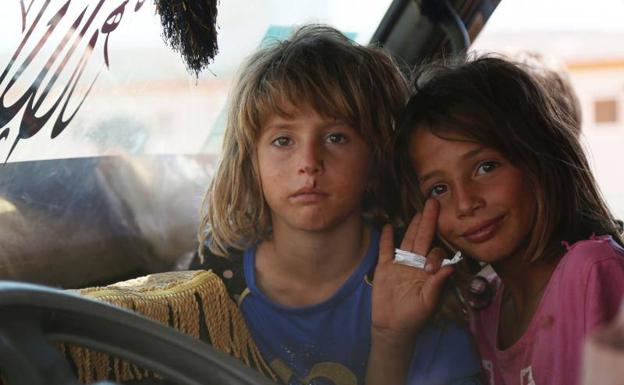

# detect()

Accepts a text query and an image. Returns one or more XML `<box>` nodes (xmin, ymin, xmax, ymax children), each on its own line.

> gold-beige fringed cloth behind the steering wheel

<box><xmin>59</xmin><ymin>270</ymin><xmax>275</xmax><ymax>383</ymax></box>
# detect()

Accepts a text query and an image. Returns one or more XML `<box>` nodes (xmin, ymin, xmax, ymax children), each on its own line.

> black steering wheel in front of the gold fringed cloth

<box><xmin>0</xmin><ymin>281</ymin><xmax>272</xmax><ymax>385</ymax></box>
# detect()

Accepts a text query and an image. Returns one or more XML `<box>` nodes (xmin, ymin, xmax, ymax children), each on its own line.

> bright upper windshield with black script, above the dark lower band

<box><xmin>0</xmin><ymin>0</ymin><xmax>390</xmax><ymax>162</ymax></box>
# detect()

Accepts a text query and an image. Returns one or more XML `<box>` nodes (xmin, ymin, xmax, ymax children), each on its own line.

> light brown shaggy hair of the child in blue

<box><xmin>199</xmin><ymin>25</ymin><xmax>408</xmax><ymax>256</ymax></box>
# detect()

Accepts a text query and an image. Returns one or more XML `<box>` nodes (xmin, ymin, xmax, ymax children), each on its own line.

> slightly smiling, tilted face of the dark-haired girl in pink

<box><xmin>409</xmin><ymin>127</ymin><xmax>537</xmax><ymax>263</ymax></box>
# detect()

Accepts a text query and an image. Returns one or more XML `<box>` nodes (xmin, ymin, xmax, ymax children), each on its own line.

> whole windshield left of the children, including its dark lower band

<box><xmin>0</xmin><ymin>0</ymin><xmax>391</xmax><ymax>287</ymax></box>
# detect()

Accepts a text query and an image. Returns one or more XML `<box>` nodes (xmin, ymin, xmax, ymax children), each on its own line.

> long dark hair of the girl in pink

<box><xmin>395</xmin><ymin>57</ymin><xmax>622</xmax><ymax>262</ymax></box>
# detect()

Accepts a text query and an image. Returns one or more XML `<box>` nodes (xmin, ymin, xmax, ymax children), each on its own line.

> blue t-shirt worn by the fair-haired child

<box><xmin>240</xmin><ymin>231</ymin><xmax>481</xmax><ymax>385</ymax></box>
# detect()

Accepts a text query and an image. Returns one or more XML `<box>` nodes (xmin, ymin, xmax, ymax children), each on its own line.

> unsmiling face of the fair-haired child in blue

<box><xmin>256</xmin><ymin>103</ymin><xmax>371</xmax><ymax>231</ymax></box>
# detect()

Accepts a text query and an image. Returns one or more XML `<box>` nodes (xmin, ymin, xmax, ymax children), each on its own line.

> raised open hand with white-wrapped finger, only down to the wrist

<box><xmin>372</xmin><ymin>199</ymin><xmax>453</xmax><ymax>342</ymax></box>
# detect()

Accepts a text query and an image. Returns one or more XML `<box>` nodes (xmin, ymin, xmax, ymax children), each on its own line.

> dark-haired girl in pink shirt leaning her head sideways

<box><xmin>382</xmin><ymin>57</ymin><xmax>624</xmax><ymax>385</ymax></box>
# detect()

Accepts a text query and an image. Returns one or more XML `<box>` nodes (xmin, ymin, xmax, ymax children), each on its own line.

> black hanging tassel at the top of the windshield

<box><xmin>154</xmin><ymin>0</ymin><xmax>218</xmax><ymax>76</ymax></box>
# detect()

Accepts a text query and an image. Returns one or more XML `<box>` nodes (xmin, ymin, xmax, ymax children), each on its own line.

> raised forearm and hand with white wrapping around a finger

<box><xmin>366</xmin><ymin>200</ymin><xmax>453</xmax><ymax>385</ymax></box>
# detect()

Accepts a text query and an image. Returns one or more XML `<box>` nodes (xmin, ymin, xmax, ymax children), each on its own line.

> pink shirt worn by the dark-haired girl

<box><xmin>471</xmin><ymin>236</ymin><xmax>624</xmax><ymax>385</ymax></box>
